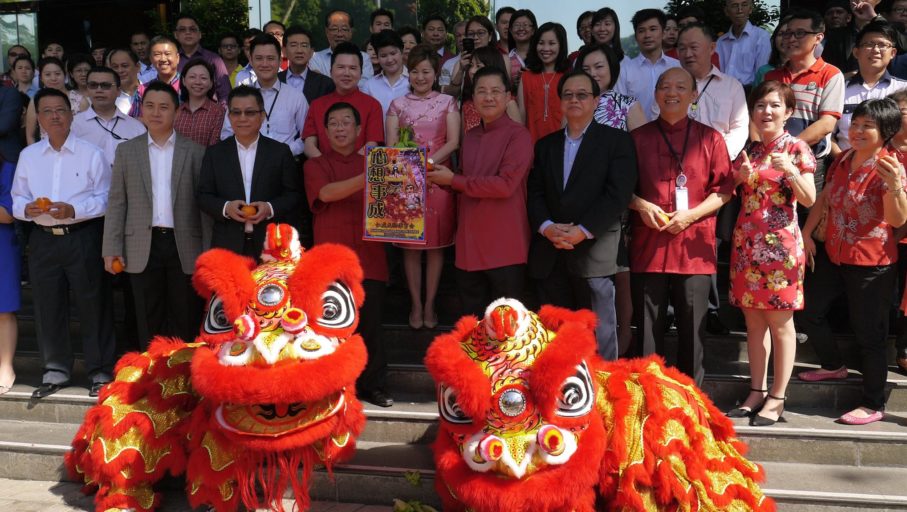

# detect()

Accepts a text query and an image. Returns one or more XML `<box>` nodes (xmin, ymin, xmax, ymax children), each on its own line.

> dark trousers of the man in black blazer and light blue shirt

<box><xmin>536</xmin><ymin>268</ymin><xmax>617</xmax><ymax>361</ymax></box>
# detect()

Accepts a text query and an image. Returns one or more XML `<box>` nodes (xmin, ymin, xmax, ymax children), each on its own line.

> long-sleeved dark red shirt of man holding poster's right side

<box><xmin>450</xmin><ymin>114</ymin><xmax>533</xmax><ymax>272</ymax></box>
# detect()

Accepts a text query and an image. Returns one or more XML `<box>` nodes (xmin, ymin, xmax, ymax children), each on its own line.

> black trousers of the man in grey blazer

<box><xmin>129</xmin><ymin>229</ymin><xmax>203</xmax><ymax>350</ymax></box>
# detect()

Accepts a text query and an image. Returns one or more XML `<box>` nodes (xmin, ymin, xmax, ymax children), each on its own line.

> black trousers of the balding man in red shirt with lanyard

<box><xmin>630</xmin><ymin>273</ymin><xmax>711</xmax><ymax>385</ymax></box>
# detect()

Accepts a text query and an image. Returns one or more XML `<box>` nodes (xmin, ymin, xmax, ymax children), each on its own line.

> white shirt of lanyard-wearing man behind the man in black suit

<box><xmin>220</xmin><ymin>80</ymin><xmax>309</xmax><ymax>156</ymax></box>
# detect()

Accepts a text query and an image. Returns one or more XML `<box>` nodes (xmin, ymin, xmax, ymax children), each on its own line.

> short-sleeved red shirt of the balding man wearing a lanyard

<box><xmin>630</xmin><ymin>118</ymin><xmax>734</xmax><ymax>274</ymax></box>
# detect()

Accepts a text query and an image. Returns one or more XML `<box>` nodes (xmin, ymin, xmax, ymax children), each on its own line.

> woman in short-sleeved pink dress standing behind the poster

<box><xmin>384</xmin><ymin>45</ymin><xmax>460</xmax><ymax>329</ymax></box>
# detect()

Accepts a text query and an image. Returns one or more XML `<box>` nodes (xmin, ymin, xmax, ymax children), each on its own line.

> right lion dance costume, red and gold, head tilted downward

<box><xmin>426</xmin><ymin>299</ymin><xmax>774</xmax><ymax>512</ymax></box>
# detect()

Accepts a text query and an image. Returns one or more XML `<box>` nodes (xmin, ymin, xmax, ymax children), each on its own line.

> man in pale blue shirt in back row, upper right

<box><xmin>718</xmin><ymin>0</ymin><xmax>772</xmax><ymax>87</ymax></box>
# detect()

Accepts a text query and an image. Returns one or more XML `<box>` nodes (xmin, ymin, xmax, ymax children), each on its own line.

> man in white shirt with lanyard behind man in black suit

<box><xmin>231</xmin><ymin>34</ymin><xmax>309</xmax><ymax>156</ymax></box>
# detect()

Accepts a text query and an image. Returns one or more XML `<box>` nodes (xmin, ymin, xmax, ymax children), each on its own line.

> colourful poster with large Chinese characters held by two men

<box><xmin>363</xmin><ymin>147</ymin><xmax>426</xmax><ymax>244</ymax></box>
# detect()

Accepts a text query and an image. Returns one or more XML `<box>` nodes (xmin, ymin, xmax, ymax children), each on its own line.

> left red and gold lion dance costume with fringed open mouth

<box><xmin>66</xmin><ymin>224</ymin><xmax>366</xmax><ymax>512</ymax></box>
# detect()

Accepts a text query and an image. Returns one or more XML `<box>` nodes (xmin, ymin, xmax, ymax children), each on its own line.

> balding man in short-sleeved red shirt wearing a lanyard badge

<box><xmin>630</xmin><ymin>68</ymin><xmax>734</xmax><ymax>383</ymax></box>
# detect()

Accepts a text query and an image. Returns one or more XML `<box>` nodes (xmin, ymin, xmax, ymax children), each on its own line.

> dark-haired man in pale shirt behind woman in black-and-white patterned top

<box><xmin>614</xmin><ymin>9</ymin><xmax>680</xmax><ymax>121</ymax></box>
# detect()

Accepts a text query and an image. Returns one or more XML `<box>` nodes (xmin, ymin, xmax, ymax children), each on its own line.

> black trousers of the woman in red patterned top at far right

<box><xmin>798</xmin><ymin>244</ymin><xmax>897</xmax><ymax>411</ymax></box>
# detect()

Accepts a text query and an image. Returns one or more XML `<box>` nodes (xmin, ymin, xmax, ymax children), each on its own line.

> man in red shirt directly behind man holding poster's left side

<box><xmin>302</xmin><ymin>43</ymin><xmax>384</xmax><ymax>158</ymax></box>
